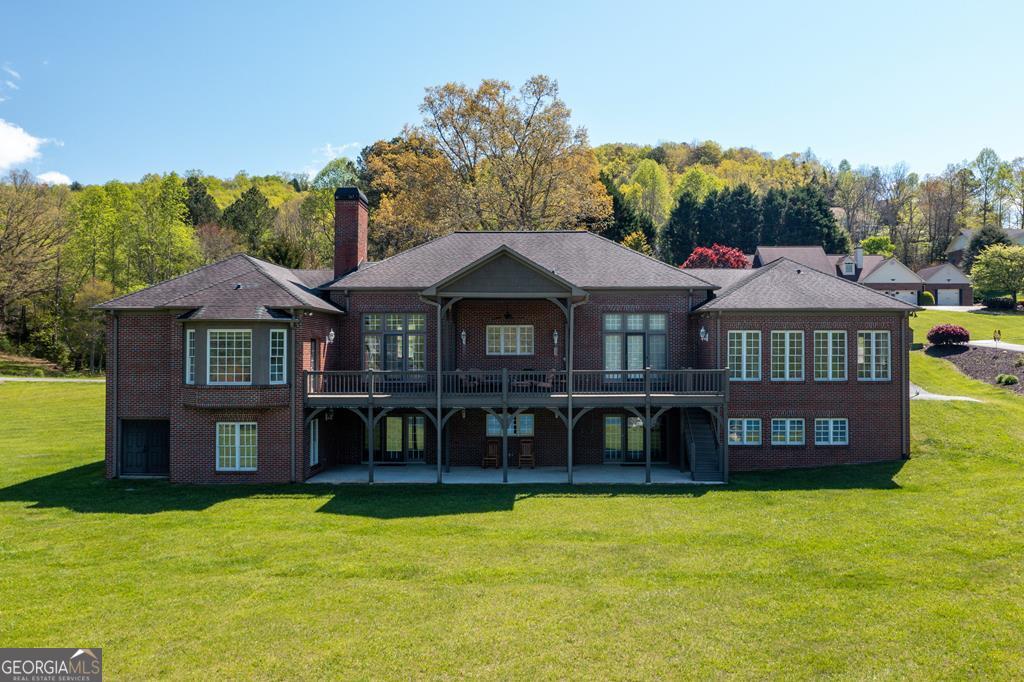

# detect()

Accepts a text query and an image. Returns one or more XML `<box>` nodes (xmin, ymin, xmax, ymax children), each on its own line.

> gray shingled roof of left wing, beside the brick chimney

<box><xmin>96</xmin><ymin>254</ymin><xmax>339</xmax><ymax>319</ymax></box>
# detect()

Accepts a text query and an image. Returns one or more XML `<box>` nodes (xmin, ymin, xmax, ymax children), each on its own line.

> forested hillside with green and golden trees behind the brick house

<box><xmin>6</xmin><ymin>76</ymin><xmax>1024</xmax><ymax>369</ymax></box>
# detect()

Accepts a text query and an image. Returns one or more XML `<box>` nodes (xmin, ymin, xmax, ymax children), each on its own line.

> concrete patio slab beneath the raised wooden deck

<box><xmin>306</xmin><ymin>464</ymin><xmax>703</xmax><ymax>485</ymax></box>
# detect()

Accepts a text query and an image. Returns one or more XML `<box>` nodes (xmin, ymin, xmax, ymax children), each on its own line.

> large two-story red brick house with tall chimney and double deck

<box><xmin>100</xmin><ymin>188</ymin><xmax>916</xmax><ymax>483</ymax></box>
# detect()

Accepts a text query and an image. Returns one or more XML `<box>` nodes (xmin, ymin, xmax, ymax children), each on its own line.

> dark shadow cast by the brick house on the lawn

<box><xmin>0</xmin><ymin>462</ymin><xmax>903</xmax><ymax>519</ymax></box>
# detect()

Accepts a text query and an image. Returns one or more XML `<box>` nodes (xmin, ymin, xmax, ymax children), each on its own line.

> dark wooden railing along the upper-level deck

<box><xmin>305</xmin><ymin>369</ymin><xmax>727</xmax><ymax>398</ymax></box>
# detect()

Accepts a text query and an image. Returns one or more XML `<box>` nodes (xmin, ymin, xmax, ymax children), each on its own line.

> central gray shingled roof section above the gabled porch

<box><xmin>330</xmin><ymin>231</ymin><xmax>714</xmax><ymax>289</ymax></box>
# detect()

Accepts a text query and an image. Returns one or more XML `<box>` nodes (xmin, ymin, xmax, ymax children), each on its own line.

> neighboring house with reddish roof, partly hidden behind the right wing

<box><xmin>752</xmin><ymin>241</ymin><xmax>925</xmax><ymax>305</ymax></box>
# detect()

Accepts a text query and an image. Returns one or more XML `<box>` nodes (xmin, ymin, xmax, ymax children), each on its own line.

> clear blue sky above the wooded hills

<box><xmin>0</xmin><ymin>0</ymin><xmax>1024</xmax><ymax>182</ymax></box>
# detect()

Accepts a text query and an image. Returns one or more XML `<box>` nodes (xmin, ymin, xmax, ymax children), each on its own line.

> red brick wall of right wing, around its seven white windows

<box><xmin>694</xmin><ymin>313</ymin><xmax>909</xmax><ymax>471</ymax></box>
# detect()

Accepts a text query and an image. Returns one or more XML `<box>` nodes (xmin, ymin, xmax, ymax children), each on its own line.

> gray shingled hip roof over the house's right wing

<box><xmin>699</xmin><ymin>258</ymin><xmax>920</xmax><ymax>310</ymax></box>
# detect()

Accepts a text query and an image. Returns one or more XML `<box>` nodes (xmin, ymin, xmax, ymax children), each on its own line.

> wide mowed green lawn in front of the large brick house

<box><xmin>0</xmin><ymin>366</ymin><xmax>1024</xmax><ymax>679</ymax></box>
